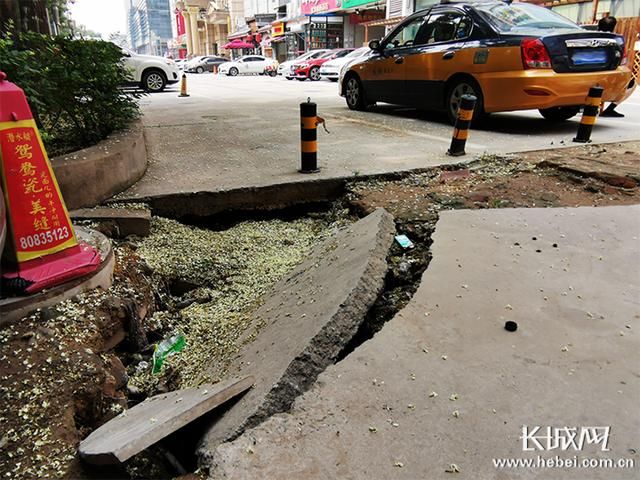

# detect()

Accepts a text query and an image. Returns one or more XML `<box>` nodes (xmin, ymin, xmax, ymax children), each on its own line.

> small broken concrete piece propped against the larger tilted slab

<box><xmin>78</xmin><ymin>376</ymin><xmax>255</xmax><ymax>465</ymax></box>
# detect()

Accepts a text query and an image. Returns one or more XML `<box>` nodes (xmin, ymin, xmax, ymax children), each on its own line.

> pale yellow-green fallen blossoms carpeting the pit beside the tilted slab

<box><xmin>129</xmin><ymin>218</ymin><xmax>348</xmax><ymax>392</ymax></box>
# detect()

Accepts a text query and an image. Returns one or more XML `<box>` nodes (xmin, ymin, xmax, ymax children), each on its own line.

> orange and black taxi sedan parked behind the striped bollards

<box><xmin>340</xmin><ymin>0</ymin><xmax>635</xmax><ymax>122</ymax></box>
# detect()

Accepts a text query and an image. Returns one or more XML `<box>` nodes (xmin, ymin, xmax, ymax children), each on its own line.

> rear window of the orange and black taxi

<box><xmin>476</xmin><ymin>3</ymin><xmax>580</xmax><ymax>33</ymax></box>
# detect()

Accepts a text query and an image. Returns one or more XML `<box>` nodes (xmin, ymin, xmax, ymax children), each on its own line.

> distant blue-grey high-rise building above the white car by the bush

<box><xmin>126</xmin><ymin>0</ymin><xmax>173</xmax><ymax>55</ymax></box>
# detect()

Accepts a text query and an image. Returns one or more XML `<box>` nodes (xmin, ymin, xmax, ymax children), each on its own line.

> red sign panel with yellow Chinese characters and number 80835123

<box><xmin>0</xmin><ymin>120</ymin><xmax>77</xmax><ymax>262</ymax></box>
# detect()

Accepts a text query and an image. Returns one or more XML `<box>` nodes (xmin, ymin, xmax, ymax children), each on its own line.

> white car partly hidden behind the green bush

<box><xmin>120</xmin><ymin>47</ymin><xmax>179</xmax><ymax>92</ymax></box>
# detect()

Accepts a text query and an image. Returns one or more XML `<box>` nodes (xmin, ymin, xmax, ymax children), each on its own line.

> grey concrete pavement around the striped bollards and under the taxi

<box><xmin>118</xmin><ymin>75</ymin><xmax>640</xmax><ymax>203</ymax></box>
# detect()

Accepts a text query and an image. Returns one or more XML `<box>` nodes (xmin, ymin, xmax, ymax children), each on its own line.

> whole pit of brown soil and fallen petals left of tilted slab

<box><xmin>0</xmin><ymin>216</ymin><xmax>342</xmax><ymax>479</ymax></box>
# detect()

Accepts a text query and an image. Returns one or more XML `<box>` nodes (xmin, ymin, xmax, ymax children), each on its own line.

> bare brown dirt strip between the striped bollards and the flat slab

<box><xmin>347</xmin><ymin>142</ymin><xmax>640</xmax><ymax>224</ymax></box>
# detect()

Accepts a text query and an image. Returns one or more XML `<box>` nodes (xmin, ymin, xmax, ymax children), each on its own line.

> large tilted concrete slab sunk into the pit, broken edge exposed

<box><xmin>199</xmin><ymin>209</ymin><xmax>395</xmax><ymax>463</ymax></box>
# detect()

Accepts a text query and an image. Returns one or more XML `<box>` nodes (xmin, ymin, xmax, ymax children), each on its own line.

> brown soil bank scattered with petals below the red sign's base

<box><xmin>0</xmin><ymin>246</ymin><xmax>161</xmax><ymax>478</ymax></box>
